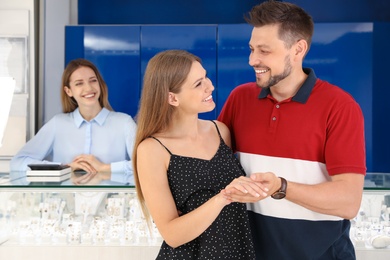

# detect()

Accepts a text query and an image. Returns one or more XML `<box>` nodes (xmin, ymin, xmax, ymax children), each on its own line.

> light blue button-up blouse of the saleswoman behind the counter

<box><xmin>10</xmin><ymin>108</ymin><xmax>136</xmax><ymax>185</ymax></box>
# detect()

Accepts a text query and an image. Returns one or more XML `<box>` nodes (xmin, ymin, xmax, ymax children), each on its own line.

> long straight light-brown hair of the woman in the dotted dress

<box><xmin>132</xmin><ymin>50</ymin><xmax>201</xmax><ymax>222</ymax></box>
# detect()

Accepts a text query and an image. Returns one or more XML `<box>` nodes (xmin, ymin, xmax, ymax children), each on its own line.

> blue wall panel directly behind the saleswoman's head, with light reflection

<box><xmin>65</xmin><ymin>26</ymin><xmax>141</xmax><ymax>116</ymax></box>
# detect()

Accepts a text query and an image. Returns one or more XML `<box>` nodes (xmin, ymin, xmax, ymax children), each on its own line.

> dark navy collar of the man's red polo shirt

<box><xmin>259</xmin><ymin>68</ymin><xmax>317</xmax><ymax>104</ymax></box>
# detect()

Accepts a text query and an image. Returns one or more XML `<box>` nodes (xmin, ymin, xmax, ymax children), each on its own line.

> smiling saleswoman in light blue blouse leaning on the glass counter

<box><xmin>10</xmin><ymin>59</ymin><xmax>136</xmax><ymax>183</ymax></box>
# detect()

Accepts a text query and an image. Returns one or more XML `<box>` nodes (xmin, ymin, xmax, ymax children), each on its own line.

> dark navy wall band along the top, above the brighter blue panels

<box><xmin>77</xmin><ymin>0</ymin><xmax>390</xmax><ymax>24</ymax></box>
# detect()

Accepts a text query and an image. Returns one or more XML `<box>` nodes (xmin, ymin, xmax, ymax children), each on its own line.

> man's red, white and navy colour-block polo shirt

<box><xmin>218</xmin><ymin>69</ymin><xmax>366</xmax><ymax>259</ymax></box>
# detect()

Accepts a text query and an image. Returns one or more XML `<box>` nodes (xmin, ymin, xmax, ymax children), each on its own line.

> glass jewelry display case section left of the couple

<box><xmin>0</xmin><ymin>173</ymin><xmax>162</xmax><ymax>260</ymax></box>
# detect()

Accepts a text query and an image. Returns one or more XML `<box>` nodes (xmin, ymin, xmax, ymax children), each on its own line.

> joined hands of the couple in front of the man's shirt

<box><xmin>225</xmin><ymin>172</ymin><xmax>280</xmax><ymax>203</ymax></box>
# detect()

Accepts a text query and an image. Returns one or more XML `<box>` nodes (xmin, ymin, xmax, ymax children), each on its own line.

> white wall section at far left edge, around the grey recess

<box><xmin>0</xmin><ymin>0</ymin><xmax>36</xmax><ymax>172</ymax></box>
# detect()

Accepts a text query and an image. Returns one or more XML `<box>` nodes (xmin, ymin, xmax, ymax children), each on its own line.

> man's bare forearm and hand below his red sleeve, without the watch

<box><xmin>227</xmin><ymin>172</ymin><xmax>364</xmax><ymax>219</ymax></box>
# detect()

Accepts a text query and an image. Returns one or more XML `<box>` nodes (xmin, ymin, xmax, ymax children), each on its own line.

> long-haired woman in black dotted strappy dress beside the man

<box><xmin>133</xmin><ymin>50</ymin><xmax>261</xmax><ymax>260</ymax></box>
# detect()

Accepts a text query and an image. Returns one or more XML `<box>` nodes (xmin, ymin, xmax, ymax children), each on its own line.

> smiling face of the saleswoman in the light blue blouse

<box><xmin>64</xmin><ymin>67</ymin><xmax>100</xmax><ymax>107</ymax></box>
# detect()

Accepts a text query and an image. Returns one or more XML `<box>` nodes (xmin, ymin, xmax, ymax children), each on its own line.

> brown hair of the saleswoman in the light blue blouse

<box><xmin>61</xmin><ymin>59</ymin><xmax>112</xmax><ymax>113</ymax></box>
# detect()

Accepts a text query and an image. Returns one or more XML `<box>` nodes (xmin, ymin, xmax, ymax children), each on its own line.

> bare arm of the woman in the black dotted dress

<box><xmin>137</xmin><ymin>139</ymin><xmax>231</xmax><ymax>247</ymax></box>
